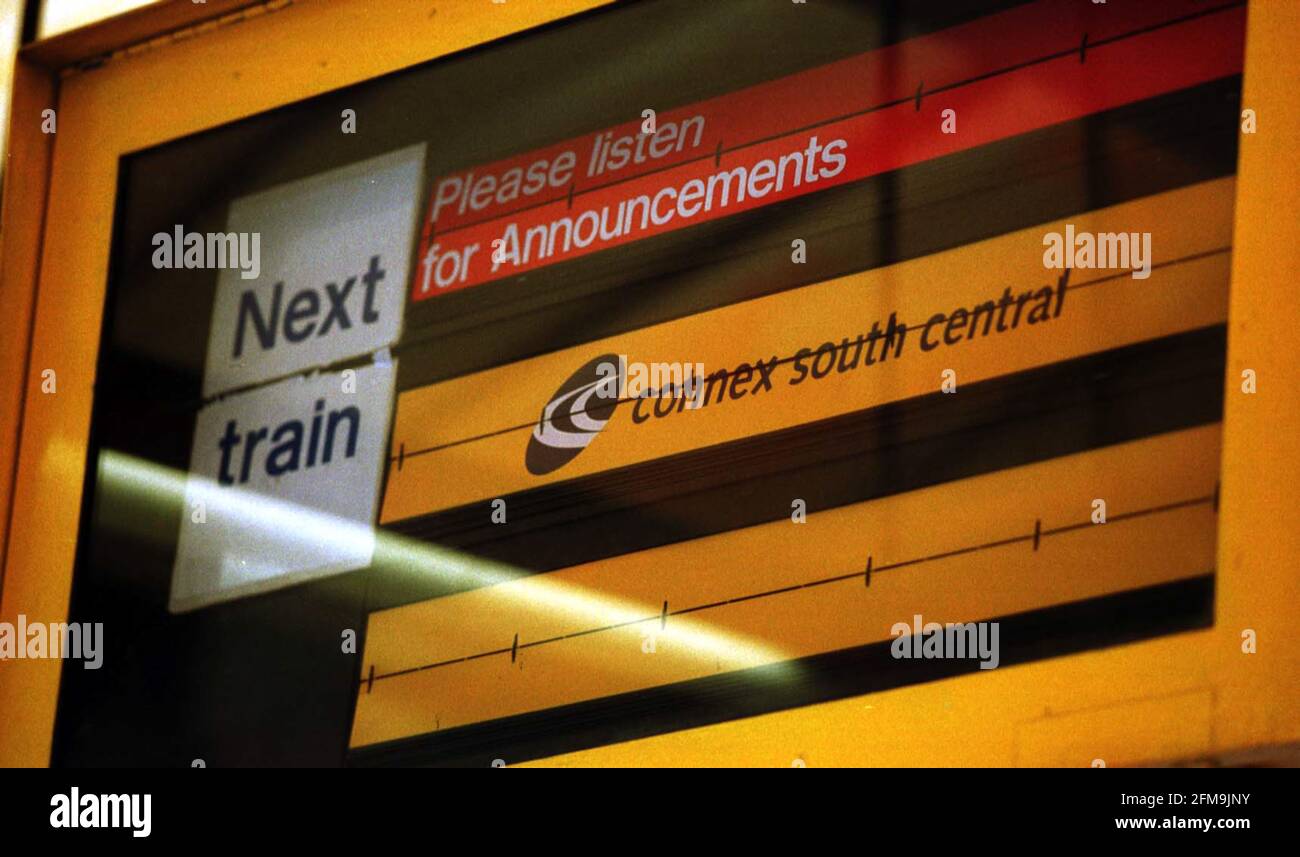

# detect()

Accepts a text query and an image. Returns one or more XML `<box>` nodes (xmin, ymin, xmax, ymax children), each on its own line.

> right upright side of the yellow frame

<box><xmin>1214</xmin><ymin>1</ymin><xmax>1300</xmax><ymax>748</ymax></box>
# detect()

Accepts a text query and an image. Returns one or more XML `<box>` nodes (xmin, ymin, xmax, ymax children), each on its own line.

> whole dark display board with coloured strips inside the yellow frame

<box><xmin>56</xmin><ymin>0</ymin><xmax>1247</xmax><ymax>765</ymax></box>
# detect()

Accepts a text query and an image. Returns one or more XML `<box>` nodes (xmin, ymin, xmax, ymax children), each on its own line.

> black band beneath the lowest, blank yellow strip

<box><xmin>347</xmin><ymin>577</ymin><xmax>1216</xmax><ymax>767</ymax></box>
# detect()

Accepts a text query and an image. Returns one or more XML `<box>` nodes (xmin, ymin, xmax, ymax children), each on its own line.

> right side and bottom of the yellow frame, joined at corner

<box><xmin>520</xmin><ymin>3</ymin><xmax>1300</xmax><ymax>767</ymax></box>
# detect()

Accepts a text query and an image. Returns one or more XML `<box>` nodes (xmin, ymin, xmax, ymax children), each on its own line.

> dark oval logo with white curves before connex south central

<box><xmin>524</xmin><ymin>354</ymin><xmax>621</xmax><ymax>476</ymax></box>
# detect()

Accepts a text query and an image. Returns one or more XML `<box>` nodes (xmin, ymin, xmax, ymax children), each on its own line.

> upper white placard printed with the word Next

<box><xmin>203</xmin><ymin>143</ymin><xmax>425</xmax><ymax>398</ymax></box>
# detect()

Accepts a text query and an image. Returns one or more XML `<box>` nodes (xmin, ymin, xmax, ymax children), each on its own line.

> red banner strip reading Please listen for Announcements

<box><xmin>412</xmin><ymin>0</ymin><xmax>1245</xmax><ymax>300</ymax></box>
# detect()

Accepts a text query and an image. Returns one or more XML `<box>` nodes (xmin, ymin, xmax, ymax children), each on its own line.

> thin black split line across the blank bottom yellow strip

<box><xmin>371</xmin><ymin>494</ymin><xmax>1214</xmax><ymax>683</ymax></box>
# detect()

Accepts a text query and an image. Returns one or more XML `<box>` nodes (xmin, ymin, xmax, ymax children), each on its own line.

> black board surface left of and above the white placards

<box><xmin>52</xmin><ymin>0</ymin><xmax>1045</xmax><ymax>767</ymax></box>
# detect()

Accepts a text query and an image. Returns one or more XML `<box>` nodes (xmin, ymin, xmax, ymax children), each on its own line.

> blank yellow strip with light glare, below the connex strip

<box><xmin>352</xmin><ymin>425</ymin><xmax>1219</xmax><ymax>745</ymax></box>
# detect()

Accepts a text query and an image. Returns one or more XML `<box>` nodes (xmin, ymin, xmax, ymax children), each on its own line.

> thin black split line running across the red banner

<box><xmin>429</xmin><ymin>0</ymin><xmax>1245</xmax><ymax>241</ymax></box>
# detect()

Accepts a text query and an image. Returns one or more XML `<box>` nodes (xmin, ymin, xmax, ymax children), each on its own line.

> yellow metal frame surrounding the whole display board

<box><xmin>0</xmin><ymin>0</ymin><xmax>1300</xmax><ymax>766</ymax></box>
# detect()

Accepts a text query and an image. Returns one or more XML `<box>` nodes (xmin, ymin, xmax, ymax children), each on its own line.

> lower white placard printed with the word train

<box><xmin>169</xmin><ymin>363</ymin><xmax>395</xmax><ymax>613</ymax></box>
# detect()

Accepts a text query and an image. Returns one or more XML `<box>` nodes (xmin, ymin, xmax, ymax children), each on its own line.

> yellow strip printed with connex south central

<box><xmin>381</xmin><ymin>178</ymin><xmax>1234</xmax><ymax>523</ymax></box>
